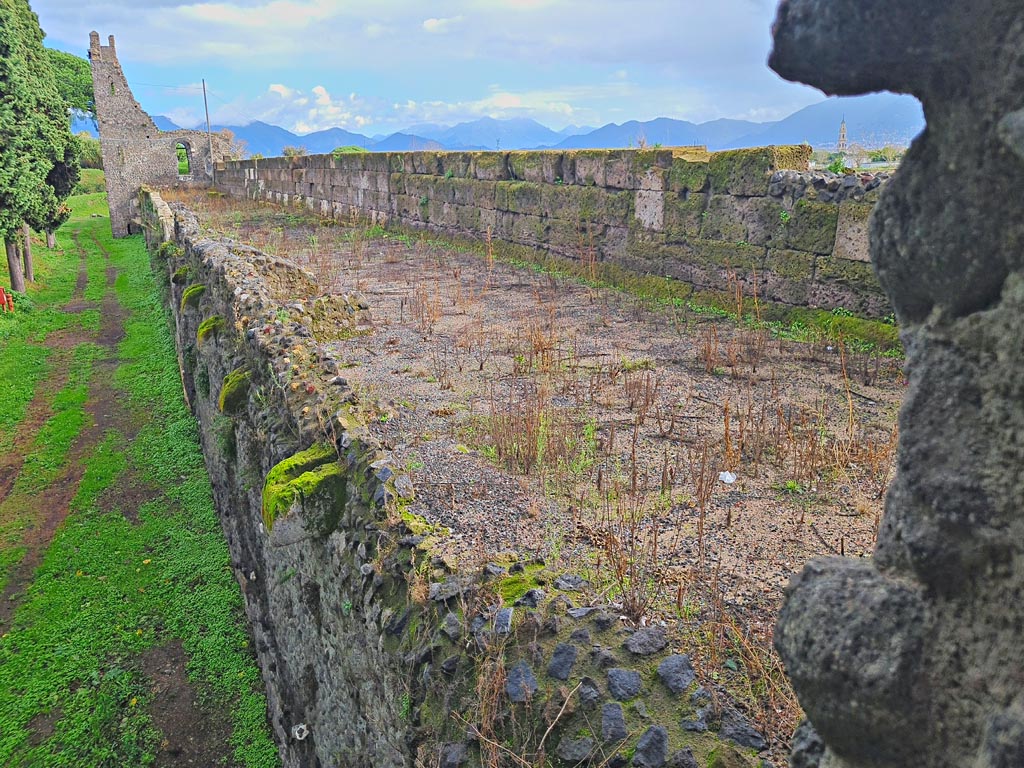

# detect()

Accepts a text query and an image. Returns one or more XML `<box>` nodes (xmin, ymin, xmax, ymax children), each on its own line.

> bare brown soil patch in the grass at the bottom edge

<box><xmin>142</xmin><ymin>640</ymin><xmax>236</xmax><ymax>768</ymax></box>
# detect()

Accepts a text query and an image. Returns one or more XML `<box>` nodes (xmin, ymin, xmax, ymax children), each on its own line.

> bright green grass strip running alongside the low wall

<box><xmin>0</xmin><ymin>198</ymin><xmax>279</xmax><ymax>768</ymax></box>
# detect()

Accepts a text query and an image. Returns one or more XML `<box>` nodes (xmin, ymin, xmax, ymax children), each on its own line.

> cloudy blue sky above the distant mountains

<box><xmin>31</xmin><ymin>0</ymin><xmax>822</xmax><ymax>134</ymax></box>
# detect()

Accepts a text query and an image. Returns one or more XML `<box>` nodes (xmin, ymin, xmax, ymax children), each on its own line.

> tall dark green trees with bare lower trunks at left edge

<box><xmin>0</xmin><ymin>0</ymin><xmax>92</xmax><ymax>292</ymax></box>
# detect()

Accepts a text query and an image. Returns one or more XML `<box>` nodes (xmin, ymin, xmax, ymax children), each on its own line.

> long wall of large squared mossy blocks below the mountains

<box><xmin>217</xmin><ymin>146</ymin><xmax>891</xmax><ymax>316</ymax></box>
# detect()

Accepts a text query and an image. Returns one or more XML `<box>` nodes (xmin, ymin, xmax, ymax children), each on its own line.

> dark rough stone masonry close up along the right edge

<box><xmin>770</xmin><ymin>0</ymin><xmax>1024</xmax><ymax>768</ymax></box>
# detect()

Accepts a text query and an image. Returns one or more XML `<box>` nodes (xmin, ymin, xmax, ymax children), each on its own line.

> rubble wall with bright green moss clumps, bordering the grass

<box><xmin>140</xmin><ymin>190</ymin><xmax>766</xmax><ymax>768</ymax></box>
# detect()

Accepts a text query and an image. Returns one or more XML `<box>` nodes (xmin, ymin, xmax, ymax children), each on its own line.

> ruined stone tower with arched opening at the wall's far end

<box><xmin>89</xmin><ymin>32</ymin><xmax>228</xmax><ymax>238</ymax></box>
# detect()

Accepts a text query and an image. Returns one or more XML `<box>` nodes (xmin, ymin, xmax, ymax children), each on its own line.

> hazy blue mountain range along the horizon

<box><xmin>72</xmin><ymin>93</ymin><xmax>925</xmax><ymax>157</ymax></box>
